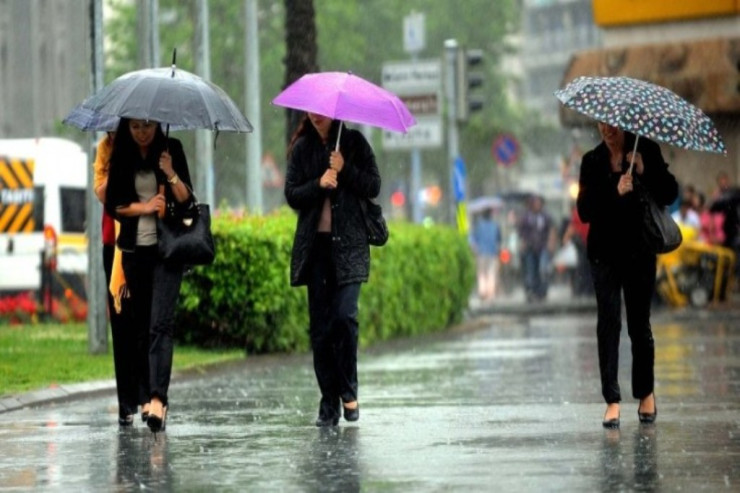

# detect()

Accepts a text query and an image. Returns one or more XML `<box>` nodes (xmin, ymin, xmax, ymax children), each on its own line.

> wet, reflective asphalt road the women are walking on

<box><xmin>0</xmin><ymin>314</ymin><xmax>740</xmax><ymax>492</ymax></box>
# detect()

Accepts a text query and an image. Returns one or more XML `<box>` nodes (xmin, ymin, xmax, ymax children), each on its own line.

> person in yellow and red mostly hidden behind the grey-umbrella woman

<box><xmin>93</xmin><ymin>132</ymin><xmax>142</xmax><ymax>426</ymax></box>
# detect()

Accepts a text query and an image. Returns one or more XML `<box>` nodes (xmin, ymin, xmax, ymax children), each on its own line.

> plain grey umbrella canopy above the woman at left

<box><xmin>69</xmin><ymin>66</ymin><xmax>252</xmax><ymax>132</ymax></box>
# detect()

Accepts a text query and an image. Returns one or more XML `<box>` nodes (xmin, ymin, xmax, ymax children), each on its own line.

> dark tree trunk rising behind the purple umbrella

<box><xmin>285</xmin><ymin>0</ymin><xmax>319</xmax><ymax>142</ymax></box>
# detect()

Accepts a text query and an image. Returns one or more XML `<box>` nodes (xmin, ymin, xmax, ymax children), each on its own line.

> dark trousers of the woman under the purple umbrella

<box><xmin>308</xmin><ymin>233</ymin><xmax>361</xmax><ymax>419</ymax></box>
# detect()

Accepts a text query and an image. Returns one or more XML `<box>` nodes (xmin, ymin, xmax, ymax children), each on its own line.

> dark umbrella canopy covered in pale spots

<box><xmin>554</xmin><ymin>76</ymin><xmax>727</xmax><ymax>154</ymax></box>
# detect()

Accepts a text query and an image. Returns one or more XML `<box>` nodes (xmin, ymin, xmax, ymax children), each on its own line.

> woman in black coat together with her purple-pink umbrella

<box><xmin>273</xmin><ymin>72</ymin><xmax>415</xmax><ymax>426</ymax></box>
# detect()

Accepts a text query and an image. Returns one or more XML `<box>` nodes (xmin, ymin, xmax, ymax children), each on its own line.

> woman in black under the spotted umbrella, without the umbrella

<box><xmin>577</xmin><ymin>122</ymin><xmax>678</xmax><ymax>428</ymax></box>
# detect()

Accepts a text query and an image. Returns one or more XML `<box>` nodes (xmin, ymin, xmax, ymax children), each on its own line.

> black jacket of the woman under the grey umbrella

<box><xmin>105</xmin><ymin>138</ymin><xmax>193</xmax><ymax>252</ymax></box>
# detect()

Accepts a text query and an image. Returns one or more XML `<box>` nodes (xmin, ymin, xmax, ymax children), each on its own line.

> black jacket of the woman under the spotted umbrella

<box><xmin>577</xmin><ymin>133</ymin><xmax>678</xmax><ymax>261</ymax></box>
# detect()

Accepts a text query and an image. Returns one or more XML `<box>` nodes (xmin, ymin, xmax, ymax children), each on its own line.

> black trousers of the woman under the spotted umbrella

<box><xmin>591</xmin><ymin>255</ymin><xmax>656</xmax><ymax>404</ymax></box>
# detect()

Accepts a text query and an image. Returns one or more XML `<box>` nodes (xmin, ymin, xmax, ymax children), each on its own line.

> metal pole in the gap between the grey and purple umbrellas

<box><xmin>244</xmin><ymin>0</ymin><xmax>262</xmax><ymax>214</ymax></box>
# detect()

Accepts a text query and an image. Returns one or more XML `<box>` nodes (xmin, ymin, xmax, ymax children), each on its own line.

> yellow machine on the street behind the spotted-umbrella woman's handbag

<box><xmin>656</xmin><ymin>227</ymin><xmax>736</xmax><ymax>307</ymax></box>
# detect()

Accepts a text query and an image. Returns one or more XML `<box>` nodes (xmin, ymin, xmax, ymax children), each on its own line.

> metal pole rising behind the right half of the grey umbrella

<box><xmin>195</xmin><ymin>0</ymin><xmax>215</xmax><ymax>206</ymax></box>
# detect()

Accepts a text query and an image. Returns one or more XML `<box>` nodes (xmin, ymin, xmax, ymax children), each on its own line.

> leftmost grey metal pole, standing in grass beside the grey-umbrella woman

<box><xmin>86</xmin><ymin>0</ymin><xmax>108</xmax><ymax>354</ymax></box>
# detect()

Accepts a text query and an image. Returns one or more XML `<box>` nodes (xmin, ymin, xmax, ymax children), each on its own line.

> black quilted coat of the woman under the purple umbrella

<box><xmin>285</xmin><ymin>127</ymin><xmax>380</xmax><ymax>286</ymax></box>
